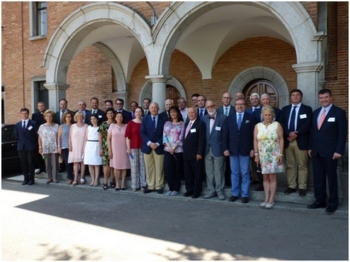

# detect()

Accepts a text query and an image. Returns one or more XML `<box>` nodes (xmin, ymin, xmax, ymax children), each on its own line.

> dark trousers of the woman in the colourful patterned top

<box><xmin>164</xmin><ymin>151</ymin><xmax>183</xmax><ymax>192</ymax></box>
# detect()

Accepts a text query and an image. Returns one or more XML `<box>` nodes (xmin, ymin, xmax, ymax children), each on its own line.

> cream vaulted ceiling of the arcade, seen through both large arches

<box><xmin>70</xmin><ymin>4</ymin><xmax>293</xmax><ymax>82</ymax></box>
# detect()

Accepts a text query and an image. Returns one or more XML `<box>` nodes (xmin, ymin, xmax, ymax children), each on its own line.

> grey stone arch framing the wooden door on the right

<box><xmin>228</xmin><ymin>66</ymin><xmax>289</xmax><ymax>108</ymax></box>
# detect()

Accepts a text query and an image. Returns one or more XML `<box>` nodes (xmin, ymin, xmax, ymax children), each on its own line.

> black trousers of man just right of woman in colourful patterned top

<box><xmin>184</xmin><ymin>160</ymin><xmax>204</xmax><ymax>194</ymax></box>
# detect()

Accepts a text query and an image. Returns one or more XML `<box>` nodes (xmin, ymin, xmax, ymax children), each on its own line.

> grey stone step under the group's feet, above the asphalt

<box><xmin>7</xmin><ymin>172</ymin><xmax>349</xmax><ymax>214</ymax></box>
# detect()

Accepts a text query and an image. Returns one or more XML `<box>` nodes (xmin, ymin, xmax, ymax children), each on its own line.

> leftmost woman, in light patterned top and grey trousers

<box><xmin>38</xmin><ymin>109</ymin><xmax>59</xmax><ymax>184</ymax></box>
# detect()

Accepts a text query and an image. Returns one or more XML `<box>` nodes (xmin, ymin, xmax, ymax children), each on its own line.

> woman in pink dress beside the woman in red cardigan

<box><xmin>107</xmin><ymin>112</ymin><xmax>130</xmax><ymax>191</ymax></box>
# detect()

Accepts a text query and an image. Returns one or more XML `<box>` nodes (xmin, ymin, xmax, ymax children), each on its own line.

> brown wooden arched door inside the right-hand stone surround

<box><xmin>243</xmin><ymin>79</ymin><xmax>279</xmax><ymax>108</ymax></box>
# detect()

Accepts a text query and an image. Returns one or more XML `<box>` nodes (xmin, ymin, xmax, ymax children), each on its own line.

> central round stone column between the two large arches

<box><xmin>146</xmin><ymin>75</ymin><xmax>169</xmax><ymax>113</ymax></box>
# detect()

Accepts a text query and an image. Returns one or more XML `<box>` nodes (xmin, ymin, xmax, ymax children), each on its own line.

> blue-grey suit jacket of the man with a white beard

<box><xmin>202</xmin><ymin>113</ymin><xmax>226</xmax><ymax>157</ymax></box>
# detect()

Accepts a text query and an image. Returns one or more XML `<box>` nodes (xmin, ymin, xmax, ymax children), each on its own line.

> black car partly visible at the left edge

<box><xmin>1</xmin><ymin>124</ymin><xmax>21</xmax><ymax>171</ymax></box>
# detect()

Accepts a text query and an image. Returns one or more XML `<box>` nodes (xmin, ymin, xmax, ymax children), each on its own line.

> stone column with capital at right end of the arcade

<box><xmin>293</xmin><ymin>62</ymin><xmax>322</xmax><ymax>110</ymax></box>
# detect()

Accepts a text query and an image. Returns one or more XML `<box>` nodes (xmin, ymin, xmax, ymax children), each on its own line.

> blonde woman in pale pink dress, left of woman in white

<box><xmin>68</xmin><ymin>112</ymin><xmax>87</xmax><ymax>186</ymax></box>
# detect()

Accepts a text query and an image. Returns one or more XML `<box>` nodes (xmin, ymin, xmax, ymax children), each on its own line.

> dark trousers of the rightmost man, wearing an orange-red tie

<box><xmin>312</xmin><ymin>155</ymin><xmax>338</xmax><ymax>208</ymax></box>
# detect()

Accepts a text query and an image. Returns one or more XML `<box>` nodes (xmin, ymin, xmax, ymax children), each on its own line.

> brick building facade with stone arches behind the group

<box><xmin>2</xmin><ymin>2</ymin><xmax>348</xmax><ymax>123</ymax></box>
